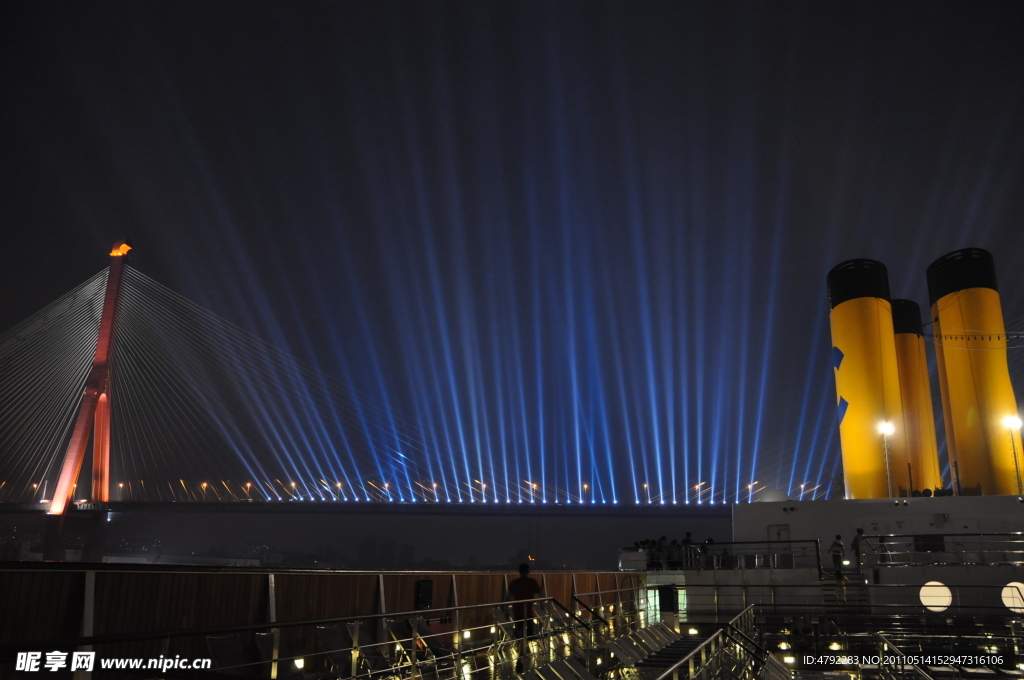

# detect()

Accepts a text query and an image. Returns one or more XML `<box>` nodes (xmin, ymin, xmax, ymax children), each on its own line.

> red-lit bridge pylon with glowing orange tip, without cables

<box><xmin>49</xmin><ymin>241</ymin><xmax>131</xmax><ymax>515</ymax></box>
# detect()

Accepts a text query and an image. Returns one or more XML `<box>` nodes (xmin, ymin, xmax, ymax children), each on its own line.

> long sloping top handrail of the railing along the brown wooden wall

<box><xmin>0</xmin><ymin>597</ymin><xmax>561</xmax><ymax>654</ymax></box>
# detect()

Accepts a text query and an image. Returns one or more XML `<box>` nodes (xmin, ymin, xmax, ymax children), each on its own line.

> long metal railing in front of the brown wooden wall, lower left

<box><xmin>0</xmin><ymin>587</ymin><xmax>647</xmax><ymax>680</ymax></box>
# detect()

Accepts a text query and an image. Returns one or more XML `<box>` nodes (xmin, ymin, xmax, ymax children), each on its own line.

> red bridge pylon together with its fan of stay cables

<box><xmin>0</xmin><ymin>244</ymin><xmax>471</xmax><ymax>514</ymax></box>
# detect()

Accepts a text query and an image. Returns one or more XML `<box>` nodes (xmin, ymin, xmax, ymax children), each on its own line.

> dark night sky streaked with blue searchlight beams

<box><xmin>0</xmin><ymin>1</ymin><xmax>1024</xmax><ymax>503</ymax></box>
